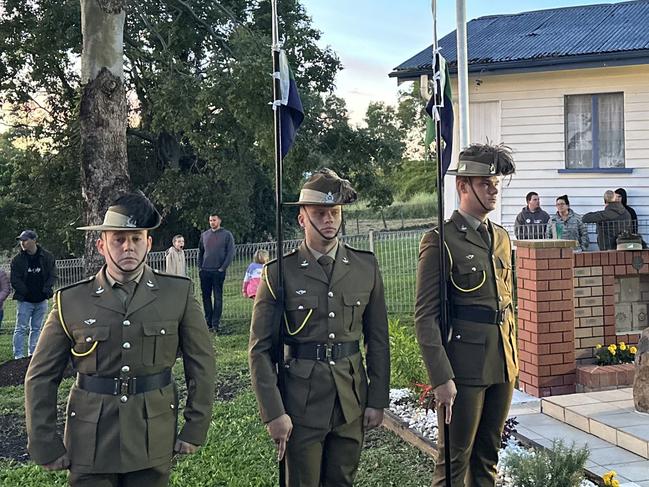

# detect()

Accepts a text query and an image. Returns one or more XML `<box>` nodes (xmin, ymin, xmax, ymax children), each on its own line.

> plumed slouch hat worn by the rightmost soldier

<box><xmin>446</xmin><ymin>144</ymin><xmax>516</xmax><ymax>176</ymax></box>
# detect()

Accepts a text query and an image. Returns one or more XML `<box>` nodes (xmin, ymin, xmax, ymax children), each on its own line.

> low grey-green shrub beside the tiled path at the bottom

<box><xmin>504</xmin><ymin>440</ymin><xmax>589</xmax><ymax>487</ymax></box>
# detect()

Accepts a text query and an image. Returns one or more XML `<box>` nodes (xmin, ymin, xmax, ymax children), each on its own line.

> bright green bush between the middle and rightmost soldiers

<box><xmin>389</xmin><ymin>319</ymin><xmax>428</xmax><ymax>388</ymax></box>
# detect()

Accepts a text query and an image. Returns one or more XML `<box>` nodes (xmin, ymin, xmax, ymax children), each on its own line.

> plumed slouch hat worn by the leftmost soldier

<box><xmin>77</xmin><ymin>191</ymin><xmax>162</xmax><ymax>231</ymax></box>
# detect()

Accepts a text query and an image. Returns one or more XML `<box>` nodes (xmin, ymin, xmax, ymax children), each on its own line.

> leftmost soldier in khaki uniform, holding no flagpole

<box><xmin>25</xmin><ymin>193</ymin><xmax>215</xmax><ymax>487</ymax></box>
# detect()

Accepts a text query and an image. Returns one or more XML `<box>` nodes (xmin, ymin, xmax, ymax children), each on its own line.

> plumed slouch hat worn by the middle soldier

<box><xmin>284</xmin><ymin>168</ymin><xmax>357</xmax><ymax>206</ymax></box>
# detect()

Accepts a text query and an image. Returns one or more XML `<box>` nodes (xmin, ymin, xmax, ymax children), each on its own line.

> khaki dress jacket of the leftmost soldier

<box><xmin>25</xmin><ymin>266</ymin><xmax>215</xmax><ymax>473</ymax></box>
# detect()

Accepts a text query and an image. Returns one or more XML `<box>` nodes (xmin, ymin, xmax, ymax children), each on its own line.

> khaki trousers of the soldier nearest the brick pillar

<box><xmin>433</xmin><ymin>382</ymin><xmax>514</xmax><ymax>487</ymax></box>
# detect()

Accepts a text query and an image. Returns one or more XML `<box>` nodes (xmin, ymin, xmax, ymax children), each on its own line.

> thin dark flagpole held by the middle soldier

<box><xmin>271</xmin><ymin>0</ymin><xmax>286</xmax><ymax>487</ymax></box>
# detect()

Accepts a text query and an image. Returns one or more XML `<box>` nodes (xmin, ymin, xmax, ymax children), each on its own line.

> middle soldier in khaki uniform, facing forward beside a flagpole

<box><xmin>249</xmin><ymin>169</ymin><xmax>390</xmax><ymax>487</ymax></box>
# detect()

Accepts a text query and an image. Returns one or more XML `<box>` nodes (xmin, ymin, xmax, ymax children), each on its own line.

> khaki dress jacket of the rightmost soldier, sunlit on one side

<box><xmin>415</xmin><ymin>211</ymin><xmax>518</xmax><ymax>387</ymax></box>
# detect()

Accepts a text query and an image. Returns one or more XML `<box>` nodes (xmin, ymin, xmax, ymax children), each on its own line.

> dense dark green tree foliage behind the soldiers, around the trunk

<box><xmin>0</xmin><ymin>0</ymin><xmax>405</xmax><ymax>257</ymax></box>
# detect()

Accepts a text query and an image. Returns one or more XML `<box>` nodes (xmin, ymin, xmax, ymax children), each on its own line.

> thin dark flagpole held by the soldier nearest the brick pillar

<box><xmin>431</xmin><ymin>0</ymin><xmax>451</xmax><ymax>487</ymax></box>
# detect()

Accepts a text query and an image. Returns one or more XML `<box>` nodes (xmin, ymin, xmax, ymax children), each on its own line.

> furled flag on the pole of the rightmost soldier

<box><xmin>424</xmin><ymin>53</ymin><xmax>453</xmax><ymax>175</ymax></box>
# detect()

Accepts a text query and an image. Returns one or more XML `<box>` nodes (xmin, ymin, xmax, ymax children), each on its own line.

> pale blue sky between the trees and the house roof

<box><xmin>302</xmin><ymin>0</ymin><xmax>632</xmax><ymax>124</ymax></box>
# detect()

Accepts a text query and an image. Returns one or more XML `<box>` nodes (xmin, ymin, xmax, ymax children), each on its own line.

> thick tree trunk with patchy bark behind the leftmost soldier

<box><xmin>79</xmin><ymin>0</ymin><xmax>130</xmax><ymax>275</ymax></box>
